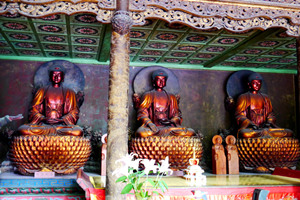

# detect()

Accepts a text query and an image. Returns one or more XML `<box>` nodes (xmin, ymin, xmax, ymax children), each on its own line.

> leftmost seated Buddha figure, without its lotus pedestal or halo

<box><xmin>18</xmin><ymin>65</ymin><xmax>83</xmax><ymax>136</ymax></box>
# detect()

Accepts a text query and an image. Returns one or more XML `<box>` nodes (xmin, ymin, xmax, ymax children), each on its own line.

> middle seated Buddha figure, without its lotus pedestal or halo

<box><xmin>136</xmin><ymin>69</ymin><xmax>195</xmax><ymax>137</ymax></box>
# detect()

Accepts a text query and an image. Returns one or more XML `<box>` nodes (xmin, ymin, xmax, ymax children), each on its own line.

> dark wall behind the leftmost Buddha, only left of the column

<box><xmin>0</xmin><ymin>60</ymin><xmax>109</xmax><ymax>133</ymax></box>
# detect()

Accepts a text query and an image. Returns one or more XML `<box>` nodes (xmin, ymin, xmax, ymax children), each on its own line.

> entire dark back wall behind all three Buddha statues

<box><xmin>0</xmin><ymin>60</ymin><xmax>296</xmax><ymax>167</ymax></box>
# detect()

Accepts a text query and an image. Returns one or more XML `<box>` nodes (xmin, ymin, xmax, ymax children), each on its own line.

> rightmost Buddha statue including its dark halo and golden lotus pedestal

<box><xmin>226</xmin><ymin>70</ymin><xmax>300</xmax><ymax>173</ymax></box>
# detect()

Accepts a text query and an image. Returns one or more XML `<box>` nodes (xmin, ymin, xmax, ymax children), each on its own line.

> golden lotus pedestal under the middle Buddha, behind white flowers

<box><xmin>129</xmin><ymin>136</ymin><xmax>203</xmax><ymax>170</ymax></box>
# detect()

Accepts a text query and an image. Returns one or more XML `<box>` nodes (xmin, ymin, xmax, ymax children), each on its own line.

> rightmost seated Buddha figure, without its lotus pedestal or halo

<box><xmin>235</xmin><ymin>73</ymin><xmax>293</xmax><ymax>138</ymax></box>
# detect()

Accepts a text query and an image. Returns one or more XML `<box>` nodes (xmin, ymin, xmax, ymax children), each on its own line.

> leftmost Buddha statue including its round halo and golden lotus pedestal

<box><xmin>9</xmin><ymin>60</ymin><xmax>91</xmax><ymax>175</ymax></box>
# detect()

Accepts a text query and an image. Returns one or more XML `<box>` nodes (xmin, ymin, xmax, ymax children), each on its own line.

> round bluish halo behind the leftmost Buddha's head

<box><xmin>34</xmin><ymin>60</ymin><xmax>85</xmax><ymax>93</ymax></box>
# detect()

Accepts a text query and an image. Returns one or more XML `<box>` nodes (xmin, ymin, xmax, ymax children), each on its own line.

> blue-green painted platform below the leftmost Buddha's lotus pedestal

<box><xmin>0</xmin><ymin>172</ymin><xmax>85</xmax><ymax>200</ymax></box>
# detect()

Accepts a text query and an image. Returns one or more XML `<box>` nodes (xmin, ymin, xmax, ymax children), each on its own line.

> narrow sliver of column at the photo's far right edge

<box><xmin>295</xmin><ymin>37</ymin><xmax>300</xmax><ymax>139</ymax></box>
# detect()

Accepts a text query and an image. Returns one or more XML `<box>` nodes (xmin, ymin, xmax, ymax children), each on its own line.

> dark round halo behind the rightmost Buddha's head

<box><xmin>226</xmin><ymin>70</ymin><xmax>267</xmax><ymax>100</ymax></box>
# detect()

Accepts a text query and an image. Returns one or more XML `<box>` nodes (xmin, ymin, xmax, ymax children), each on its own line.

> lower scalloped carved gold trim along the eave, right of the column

<box><xmin>132</xmin><ymin>6</ymin><xmax>300</xmax><ymax>36</ymax></box>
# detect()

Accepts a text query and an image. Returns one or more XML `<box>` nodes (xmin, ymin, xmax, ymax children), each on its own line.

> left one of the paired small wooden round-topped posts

<box><xmin>212</xmin><ymin>135</ymin><xmax>226</xmax><ymax>174</ymax></box>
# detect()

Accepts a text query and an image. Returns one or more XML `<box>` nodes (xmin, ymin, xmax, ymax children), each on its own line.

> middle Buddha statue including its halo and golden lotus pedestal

<box><xmin>129</xmin><ymin>66</ymin><xmax>203</xmax><ymax>170</ymax></box>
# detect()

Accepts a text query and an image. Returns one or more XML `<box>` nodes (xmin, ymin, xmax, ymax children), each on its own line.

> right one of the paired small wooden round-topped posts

<box><xmin>225</xmin><ymin>135</ymin><xmax>239</xmax><ymax>174</ymax></box>
